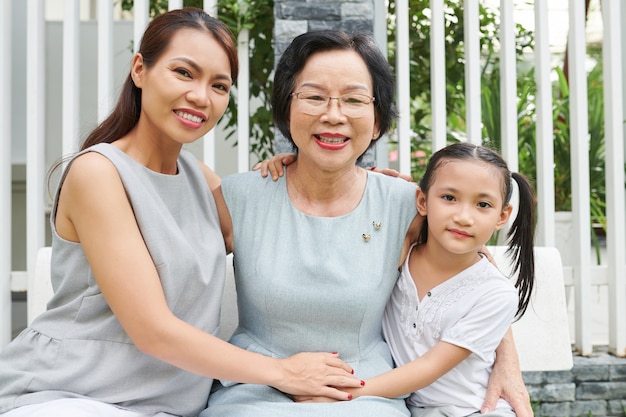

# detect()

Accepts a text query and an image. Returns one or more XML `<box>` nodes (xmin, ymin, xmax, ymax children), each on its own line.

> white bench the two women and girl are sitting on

<box><xmin>27</xmin><ymin>246</ymin><xmax>572</xmax><ymax>371</ymax></box>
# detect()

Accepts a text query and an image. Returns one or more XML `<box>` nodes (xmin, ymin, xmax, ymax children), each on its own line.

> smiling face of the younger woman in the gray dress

<box><xmin>131</xmin><ymin>28</ymin><xmax>232</xmax><ymax>145</ymax></box>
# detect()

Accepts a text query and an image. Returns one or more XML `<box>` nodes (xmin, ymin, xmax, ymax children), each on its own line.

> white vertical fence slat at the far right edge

<box><xmin>602</xmin><ymin>0</ymin><xmax>626</xmax><ymax>356</ymax></box>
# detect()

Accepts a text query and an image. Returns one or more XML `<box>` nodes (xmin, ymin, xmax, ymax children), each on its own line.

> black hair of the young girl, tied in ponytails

<box><xmin>418</xmin><ymin>142</ymin><xmax>536</xmax><ymax>319</ymax></box>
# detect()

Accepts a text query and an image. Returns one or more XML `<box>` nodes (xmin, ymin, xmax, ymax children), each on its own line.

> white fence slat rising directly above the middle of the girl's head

<box><xmin>463</xmin><ymin>0</ymin><xmax>482</xmax><ymax>145</ymax></box>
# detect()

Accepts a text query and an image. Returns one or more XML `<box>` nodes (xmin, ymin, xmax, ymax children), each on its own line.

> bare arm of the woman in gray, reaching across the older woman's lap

<box><xmin>57</xmin><ymin>152</ymin><xmax>360</xmax><ymax>399</ymax></box>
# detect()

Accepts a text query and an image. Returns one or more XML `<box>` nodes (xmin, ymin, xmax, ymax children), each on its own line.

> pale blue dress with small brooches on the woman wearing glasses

<box><xmin>201</xmin><ymin>172</ymin><xmax>417</xmax><ymax>417</ymax></box>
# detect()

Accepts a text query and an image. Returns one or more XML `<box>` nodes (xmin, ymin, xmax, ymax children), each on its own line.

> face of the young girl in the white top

<box><xmin>417</xmin><ymin>160</ymin><xmax>512</xmax><ymax>256</ymax></box>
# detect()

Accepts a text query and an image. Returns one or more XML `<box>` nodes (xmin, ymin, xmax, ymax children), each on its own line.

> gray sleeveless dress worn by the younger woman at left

<box><xmin>0</xmin><ymin>144</ymin><xmax>225</xmax><ymax>415</ymax></box>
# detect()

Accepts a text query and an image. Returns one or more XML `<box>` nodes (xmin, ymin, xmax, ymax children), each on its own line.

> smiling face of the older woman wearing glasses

<box><xmin>289</xmin><ymin>50</ymin><xmax>379</xmax><ymax>170</ymax></box>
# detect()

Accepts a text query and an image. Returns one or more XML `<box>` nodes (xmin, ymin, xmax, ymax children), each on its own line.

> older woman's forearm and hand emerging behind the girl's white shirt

<box><xmin>480</xmin><ymin>328</ymin><xmax>533</xmax><ymax>417</ymax></box>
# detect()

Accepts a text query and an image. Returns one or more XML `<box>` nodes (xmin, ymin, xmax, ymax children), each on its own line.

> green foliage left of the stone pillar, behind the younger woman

<box><xmin>119</xmin><ymin>0</ymin><xmax>274</xmax><ymax>160</ymax></box>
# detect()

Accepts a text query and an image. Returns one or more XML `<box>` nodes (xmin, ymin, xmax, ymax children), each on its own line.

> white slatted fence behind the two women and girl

<box><xmin>0</xmin><ymin>0</ymin><xmax>626</xmax><ymax>356</ymax></box>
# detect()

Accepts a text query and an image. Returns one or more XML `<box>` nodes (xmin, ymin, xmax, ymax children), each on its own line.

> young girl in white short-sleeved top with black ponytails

<box><xmin>344</xmin><ymin>143</ymin><xmax>535</xmax><ymax>417</ymax></box>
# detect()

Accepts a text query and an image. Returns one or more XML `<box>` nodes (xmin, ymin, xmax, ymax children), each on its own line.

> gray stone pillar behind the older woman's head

<box><xmin>274</xmin><ymin>0</ymin><xmax>376</xmax><ymax>166</ymax></box>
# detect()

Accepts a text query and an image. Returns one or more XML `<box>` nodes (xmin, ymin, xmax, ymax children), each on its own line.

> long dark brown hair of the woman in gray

<box><xmin>81</xmin><ymin>7</ymin><xmax>239</xmax><ymax>150</ymax></box>
